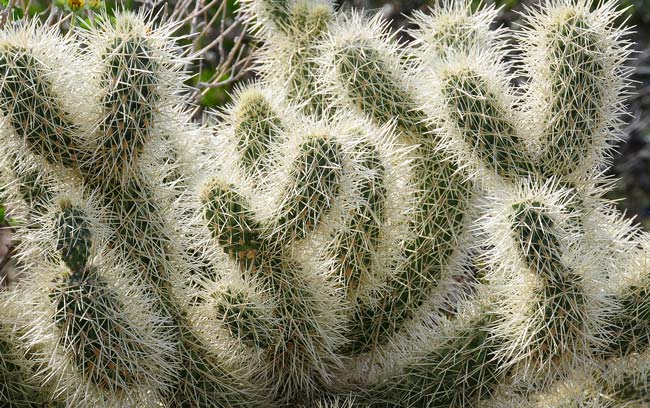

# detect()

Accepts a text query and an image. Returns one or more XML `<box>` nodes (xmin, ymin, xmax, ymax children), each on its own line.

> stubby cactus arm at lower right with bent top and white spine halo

<box><xmin>484</xmin><ymin>192</ymin><xmax>596</xmax><ymax>380</ymax></box>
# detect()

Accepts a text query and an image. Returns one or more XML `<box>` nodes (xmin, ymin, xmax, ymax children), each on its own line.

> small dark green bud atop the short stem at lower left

<box><xmin>55</xmin><ymin>201</ymin><xmax>92</xmax><ymax>271</ymax></box>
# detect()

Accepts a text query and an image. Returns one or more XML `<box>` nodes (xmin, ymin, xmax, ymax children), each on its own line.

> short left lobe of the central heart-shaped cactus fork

<box><xmin>202</xmin><ymin>179</ymin><xmax>262</xmax><ymax>267</ymax></box>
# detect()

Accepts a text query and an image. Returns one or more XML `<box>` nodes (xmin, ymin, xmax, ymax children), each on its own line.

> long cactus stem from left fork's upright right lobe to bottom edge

<box><xmin>84</xmin><ymin>13</ymin><xmax>264</xmax><ymax>407</ymax></box>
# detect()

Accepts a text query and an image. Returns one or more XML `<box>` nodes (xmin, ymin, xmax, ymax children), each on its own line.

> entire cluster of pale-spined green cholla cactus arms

<box><xmin>0</xmin><ymin>0</ymin><xmax>650</xmax><ymax>408</ymax></box>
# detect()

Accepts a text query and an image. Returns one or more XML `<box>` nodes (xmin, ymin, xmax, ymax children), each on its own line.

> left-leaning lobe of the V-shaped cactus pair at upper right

<box><xmin>424</xmin><ymin>48</ymin><xmax>537</xmax><ymax>183</ymax></box>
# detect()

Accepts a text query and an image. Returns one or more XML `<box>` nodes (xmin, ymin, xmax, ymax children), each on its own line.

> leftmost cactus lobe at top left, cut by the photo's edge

<box><xmin>0</xmin><ymin>24</ymin><xmax>84</xmax><ymax>168</ymax></box>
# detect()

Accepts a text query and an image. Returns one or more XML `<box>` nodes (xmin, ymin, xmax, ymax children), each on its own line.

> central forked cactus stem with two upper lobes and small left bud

<box><xmin>202</xmin><ymin>106</ymin><xmax>341</xmax><ymax>401</ymax></box>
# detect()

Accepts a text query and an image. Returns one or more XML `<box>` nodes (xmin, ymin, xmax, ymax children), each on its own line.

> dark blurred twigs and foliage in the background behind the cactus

<box><xmin>0</xmin><ymin>0</ymin><xmax>650</xmax><ymax>230</ymax></box>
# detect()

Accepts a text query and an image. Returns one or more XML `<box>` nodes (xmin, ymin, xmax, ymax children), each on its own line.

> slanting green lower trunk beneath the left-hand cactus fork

<box><xmin>99</xmin><ymin>179</ymin><xmax>266</xmax><ymax>407</ymax></box>
